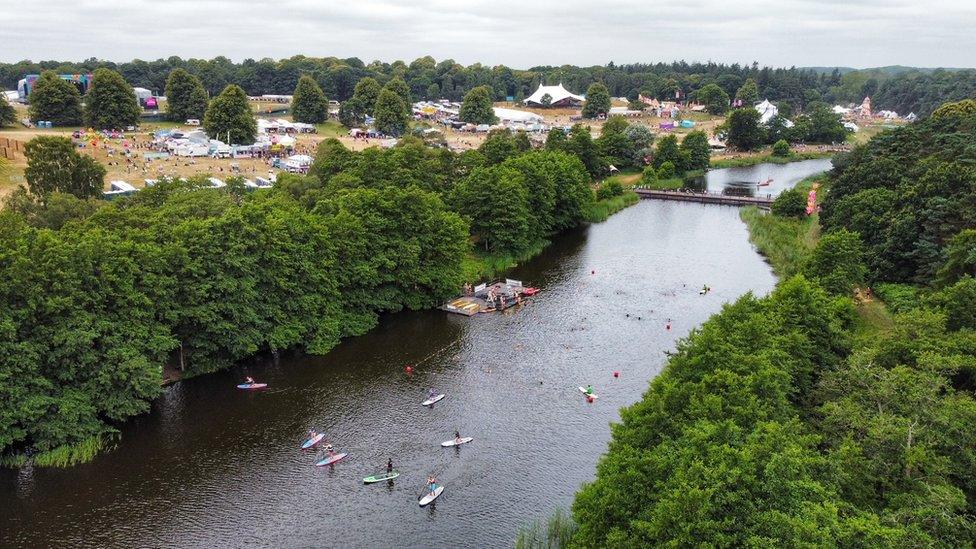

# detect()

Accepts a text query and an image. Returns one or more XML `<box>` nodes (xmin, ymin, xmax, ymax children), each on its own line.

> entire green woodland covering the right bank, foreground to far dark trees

<box><xmin>571</xmin><ymin>102</ymin><xmax>976</xmax><ymax>548</ymax></box>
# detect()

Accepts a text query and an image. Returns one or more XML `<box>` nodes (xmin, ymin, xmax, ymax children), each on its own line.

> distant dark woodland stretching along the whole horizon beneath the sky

<box><xmin>0</xmin><ymin>56</ymin><xmax>976</xmax><ymax>115</ymax></box>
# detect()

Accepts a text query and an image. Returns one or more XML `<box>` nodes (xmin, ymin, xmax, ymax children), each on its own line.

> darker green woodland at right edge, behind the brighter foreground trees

<box><xmin>822</xmin><ymin>100</ymin><xmax>976</xmax><ymax>284</ymax></box>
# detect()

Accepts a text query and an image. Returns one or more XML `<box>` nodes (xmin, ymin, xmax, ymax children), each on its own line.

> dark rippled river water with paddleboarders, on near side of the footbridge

<box><xmin>0</xmin><ymin>162</ymin><xmax>832</xmax><ymax>547</ymax></box>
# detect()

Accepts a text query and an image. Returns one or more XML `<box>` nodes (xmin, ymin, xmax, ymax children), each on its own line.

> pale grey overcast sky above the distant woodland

<box><xmin>0</xmin><ymin>0</ymin><xmax>976</xmax><ymax>68</ymax></box>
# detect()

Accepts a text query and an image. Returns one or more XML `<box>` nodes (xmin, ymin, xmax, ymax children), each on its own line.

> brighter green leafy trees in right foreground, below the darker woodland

<box><xmin>571</xmin><ymin>277</ymin><xmax>976</xmax><ymax>548</ymax></box>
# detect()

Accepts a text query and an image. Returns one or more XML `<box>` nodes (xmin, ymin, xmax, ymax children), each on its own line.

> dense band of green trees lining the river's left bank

<box><xmin>0</xmin><ymin>128</ymin><xmax>594</xmax><ymax>463</ymax></box>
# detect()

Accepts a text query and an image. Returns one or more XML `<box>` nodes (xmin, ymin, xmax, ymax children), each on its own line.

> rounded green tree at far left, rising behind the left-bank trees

<box><xmin>24</xmin><ymin>136</ymin><xmax>105</xmax><ymax>200</ymax></box>
